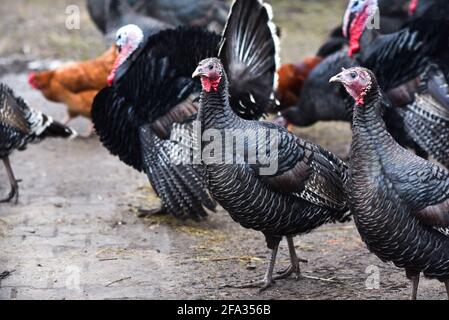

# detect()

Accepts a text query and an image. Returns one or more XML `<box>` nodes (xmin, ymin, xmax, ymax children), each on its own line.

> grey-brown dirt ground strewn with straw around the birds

<box><xmin>0</xmin><ymin>0</ymin><xmax>445</xmax><ymax>299</ymax></box>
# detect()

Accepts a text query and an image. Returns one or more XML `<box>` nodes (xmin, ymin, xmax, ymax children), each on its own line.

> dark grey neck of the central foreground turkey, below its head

<box><xmin>198</xmin><ymin>75</ymin><xmax>242</xmax><ymax>130</ymax></box>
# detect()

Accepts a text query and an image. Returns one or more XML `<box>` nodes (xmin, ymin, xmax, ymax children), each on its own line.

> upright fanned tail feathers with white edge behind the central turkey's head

<box><xmin>219</xmin><ymin>0</ymin><xmax>279</xmax><ymax>119</ymax></box>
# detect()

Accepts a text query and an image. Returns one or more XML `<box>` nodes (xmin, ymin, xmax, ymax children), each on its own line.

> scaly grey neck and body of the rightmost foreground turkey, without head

<box><xmin>349</xmin><ymin>102</ymin><xmax>449</xmax><ymax>281</ymax></box>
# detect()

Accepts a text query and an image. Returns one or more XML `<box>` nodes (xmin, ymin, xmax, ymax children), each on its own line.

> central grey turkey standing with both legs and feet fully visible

<box><xmin>193</xmin><ymin>58</ymin><xmax>350</xmax><ymax>290</ymax></box>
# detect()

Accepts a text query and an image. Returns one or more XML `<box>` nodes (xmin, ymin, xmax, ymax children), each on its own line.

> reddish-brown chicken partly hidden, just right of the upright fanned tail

<box><xmin>276</xmin><ymin>57</ymin><xmax>322</xmax><ymax>109</ymax></box>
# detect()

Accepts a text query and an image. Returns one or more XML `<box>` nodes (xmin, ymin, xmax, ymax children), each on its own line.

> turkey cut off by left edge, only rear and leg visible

<box><xmin>0</xmin><ymin>83</ymin><xmax>76</xmax><ymax>203</ymax></box>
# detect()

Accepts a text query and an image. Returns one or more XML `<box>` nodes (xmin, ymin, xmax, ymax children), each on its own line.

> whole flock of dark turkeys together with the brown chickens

<box><xmin>0</xmin><ymin>0</ymin><xmax>449</xmax><ymax>299</ymax></box>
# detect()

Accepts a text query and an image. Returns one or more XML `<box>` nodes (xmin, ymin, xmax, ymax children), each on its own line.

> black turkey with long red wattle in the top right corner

<box><xmin>348</xmin><ymin>0</ymin><xmax>449</xmax><ymax>167</ymax></box>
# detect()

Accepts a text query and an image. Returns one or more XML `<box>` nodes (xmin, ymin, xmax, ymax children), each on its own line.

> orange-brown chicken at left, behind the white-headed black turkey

<box><xmin>28</xmin><ymin>45</ymin><xmax>117</xmax><ymax>135</ymax></box>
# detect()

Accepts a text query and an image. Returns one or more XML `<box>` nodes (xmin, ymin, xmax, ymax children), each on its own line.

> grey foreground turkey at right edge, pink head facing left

<box><xmin>331</xmin><ymin>67</ymin><xmax>449</xmax><ymax>299</ymax></box>
